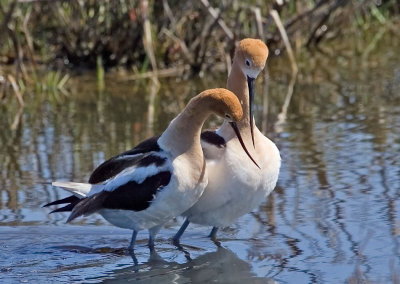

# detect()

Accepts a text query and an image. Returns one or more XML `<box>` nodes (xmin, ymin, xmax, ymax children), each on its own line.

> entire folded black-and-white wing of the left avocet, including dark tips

<box><xmin>45</xmin><ymin>137</ymin><xmax>172</xmax><ymax>222</ymax></box>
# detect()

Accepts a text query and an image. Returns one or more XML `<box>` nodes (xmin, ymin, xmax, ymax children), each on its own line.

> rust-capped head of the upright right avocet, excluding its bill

<box><xmin>233</xmin><ymin>38</ymin><xmax>268</xmax><ymax>79</ymax></box>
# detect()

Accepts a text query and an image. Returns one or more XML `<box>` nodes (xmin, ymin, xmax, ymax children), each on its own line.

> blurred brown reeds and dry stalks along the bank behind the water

<box><xmin>0</xmin><ymin>0</ymin><xmax>400</xmax><ymax>105</ymax></box>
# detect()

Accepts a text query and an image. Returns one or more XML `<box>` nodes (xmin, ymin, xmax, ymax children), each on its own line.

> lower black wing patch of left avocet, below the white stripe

<box><xmin>67</xmin><ymin>171</ymin><xmax>171</xmax><ymax>222</ymax></box>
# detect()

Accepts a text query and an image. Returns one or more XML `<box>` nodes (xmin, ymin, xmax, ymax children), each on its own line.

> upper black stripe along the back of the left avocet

<box><xmin>89</xmin><ymin>136</ymin><xmax>161</xmax><ymax>184</ymax></box>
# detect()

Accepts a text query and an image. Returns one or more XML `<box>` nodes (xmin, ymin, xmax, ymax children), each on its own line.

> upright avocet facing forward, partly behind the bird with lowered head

<box><xmin>173</xmin><ymin>39</ymin><xmax>281</xmax><ymax>242</ymax></box>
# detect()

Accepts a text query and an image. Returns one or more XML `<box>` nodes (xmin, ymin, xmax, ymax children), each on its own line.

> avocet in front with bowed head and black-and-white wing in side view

<box><xmin>45</xmin><ymin>89</ymin><xmax>255</xmax><ymax>250</ymax></box>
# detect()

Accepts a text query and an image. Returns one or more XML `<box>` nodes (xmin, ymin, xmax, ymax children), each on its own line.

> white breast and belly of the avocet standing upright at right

<box><xmin>183</xmin><ymin>132</ymin><xmax>281</xmax><ymax>227</ymax></box>
